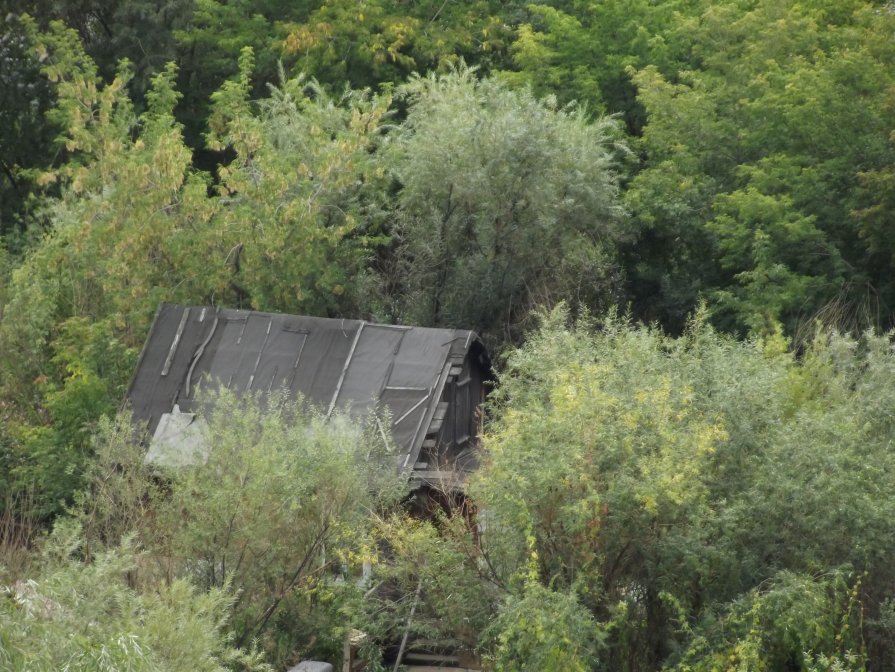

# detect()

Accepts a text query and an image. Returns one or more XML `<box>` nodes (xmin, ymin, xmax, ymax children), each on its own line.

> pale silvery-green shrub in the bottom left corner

<box><xmin>0</xmin><ymin>521</ymin><xmax>271</xmax><ymax>672</ymax></box>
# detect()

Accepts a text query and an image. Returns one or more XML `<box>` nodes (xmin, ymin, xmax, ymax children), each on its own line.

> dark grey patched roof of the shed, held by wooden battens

<box><xmin>127</xmin><ymin>304</ymin><xmax>488</xmax><ymax>467</ymax></box>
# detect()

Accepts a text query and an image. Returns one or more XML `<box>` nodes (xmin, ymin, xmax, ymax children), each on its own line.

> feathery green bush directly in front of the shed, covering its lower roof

<box><xmin>75</xmin><ymin>391</ymin><xmax>406</xmax><ymax>666</ymax></box>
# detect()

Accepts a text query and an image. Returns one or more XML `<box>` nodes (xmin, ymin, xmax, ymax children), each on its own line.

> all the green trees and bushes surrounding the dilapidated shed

<box><xmin>0</xmin><ymin>0</ymin><xmax>895</xmax><ymax>670</ymax></box>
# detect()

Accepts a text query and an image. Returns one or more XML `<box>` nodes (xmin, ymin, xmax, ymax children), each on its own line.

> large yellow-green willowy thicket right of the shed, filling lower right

<box><xmin>471</xmin><ymin>311</ymin><xmax>895</xmax><ymax>670</ymax></box>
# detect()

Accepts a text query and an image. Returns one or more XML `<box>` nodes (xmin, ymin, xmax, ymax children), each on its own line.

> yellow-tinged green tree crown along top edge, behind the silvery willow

<box><xmin>174</xmin><ymin>0</ymin><xmax>516</xmax><ymax>159</ymax></box>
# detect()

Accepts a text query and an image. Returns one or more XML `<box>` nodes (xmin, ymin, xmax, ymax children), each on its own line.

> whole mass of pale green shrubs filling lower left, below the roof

<box><xmin>0</xmin><ymin>394</ymin><xmax>406</xmax><ymax>672</ymax></box>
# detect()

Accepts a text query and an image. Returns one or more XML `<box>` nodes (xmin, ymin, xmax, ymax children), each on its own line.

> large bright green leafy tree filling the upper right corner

<box><xmin>627</xmin><ymin>1</ymin><xmax>893</xmax><ymax>332</ymax></box>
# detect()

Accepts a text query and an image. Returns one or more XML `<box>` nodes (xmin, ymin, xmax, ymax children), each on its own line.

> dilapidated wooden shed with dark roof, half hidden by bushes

<box><xmin>127</xmin><ymin>304</ymin><xmax>491</xmax><ymax>488</ymax></box>
